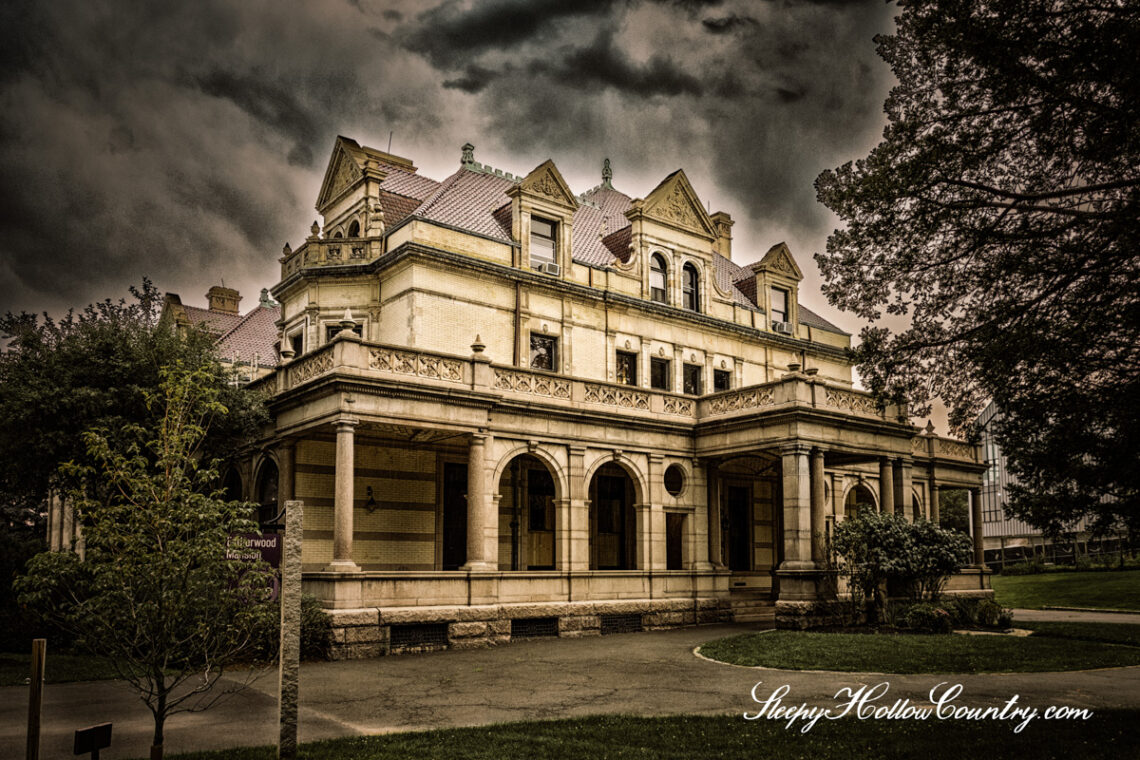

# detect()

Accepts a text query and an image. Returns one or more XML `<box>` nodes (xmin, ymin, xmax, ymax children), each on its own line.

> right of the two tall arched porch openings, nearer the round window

<box><xmin>589</xmin><ymin>461</ymin><xmax>637</xmax><ymax>570</ymax></box>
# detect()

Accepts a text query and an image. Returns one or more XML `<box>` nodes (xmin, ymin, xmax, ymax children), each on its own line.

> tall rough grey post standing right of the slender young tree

<box><xmin>277</xmin><ymin>499</ymin><xmax>304</xmax><ymax>760</ymax></box>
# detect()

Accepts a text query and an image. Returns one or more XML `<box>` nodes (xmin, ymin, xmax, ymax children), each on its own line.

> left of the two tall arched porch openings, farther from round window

<box><xmin>499</xmin><ymin>453</ymin><xmax>556</xmax><ymax>570</ymax></box>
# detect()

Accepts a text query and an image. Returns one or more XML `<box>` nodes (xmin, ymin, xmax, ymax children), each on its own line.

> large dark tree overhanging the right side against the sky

<box><xmin>816</xmin><ymin>0</ymin><xmax>1140</xmax><ymax>534</ymax></box>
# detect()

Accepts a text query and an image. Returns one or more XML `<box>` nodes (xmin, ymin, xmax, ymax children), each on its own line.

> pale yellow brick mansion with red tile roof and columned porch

<box><xmin>166</xmin><ymin>138</ymin><xmax>988</xmax><ymax>656</ymax></box>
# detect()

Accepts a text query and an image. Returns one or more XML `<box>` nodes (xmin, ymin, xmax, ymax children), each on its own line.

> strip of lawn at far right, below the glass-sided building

<box><xmin>992</xmin><ymin>571</ymin><xmax>1140</xmax><ymax>611</ymax></box>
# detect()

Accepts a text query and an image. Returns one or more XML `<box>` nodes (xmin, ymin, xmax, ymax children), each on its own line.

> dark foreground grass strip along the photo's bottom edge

<box><xmin>135</xmin><ymin>710</ymin><xmax>1140</xmax><ymax>760</ymax></box>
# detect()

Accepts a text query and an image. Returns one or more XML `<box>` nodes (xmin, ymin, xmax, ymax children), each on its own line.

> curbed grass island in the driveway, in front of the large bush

<box><xmin>701</xmin><ymin>631</ymin><xmax>1140</xmax><ymax>673</ymax></box>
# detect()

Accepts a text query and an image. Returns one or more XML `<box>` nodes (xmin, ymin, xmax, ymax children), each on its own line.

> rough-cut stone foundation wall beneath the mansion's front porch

<box><xmin>328</xmin><ymin>598</ymin><xmax>732</xmax><ymax>660</ymax></box>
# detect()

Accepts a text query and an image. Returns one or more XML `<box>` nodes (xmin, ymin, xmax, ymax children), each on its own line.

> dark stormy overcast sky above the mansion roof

<box><xmin>0</xmin><ymin>0</ymin><xmax>897</xmax><ymax>332</ymax></box>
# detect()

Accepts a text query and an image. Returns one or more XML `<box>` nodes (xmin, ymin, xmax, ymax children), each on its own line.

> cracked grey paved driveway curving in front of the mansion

<box><xmin>0</xmin><ymin>626</ymin><xmax>1140</xmax><ymax>759</ymax></box>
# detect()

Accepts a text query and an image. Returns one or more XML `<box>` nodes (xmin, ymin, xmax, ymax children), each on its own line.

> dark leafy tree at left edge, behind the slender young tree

<box><xmin>0</xmin><ymin>280</ymin><xmax>267</xmax><ymax>524</ymax></box>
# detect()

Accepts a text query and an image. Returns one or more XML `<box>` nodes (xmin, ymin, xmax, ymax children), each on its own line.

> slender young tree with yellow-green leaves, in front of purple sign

<box><xmin>17</xmin><ymin>363</ymin><xmax>270</xmax><ymax>758</ymax></box>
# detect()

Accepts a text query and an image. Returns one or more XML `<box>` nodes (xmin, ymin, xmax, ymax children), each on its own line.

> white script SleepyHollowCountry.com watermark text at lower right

<box><xmin>744</xmin><ymin>681</ymin><xmax>1092</xmax><ymax>734</ymax></box>
